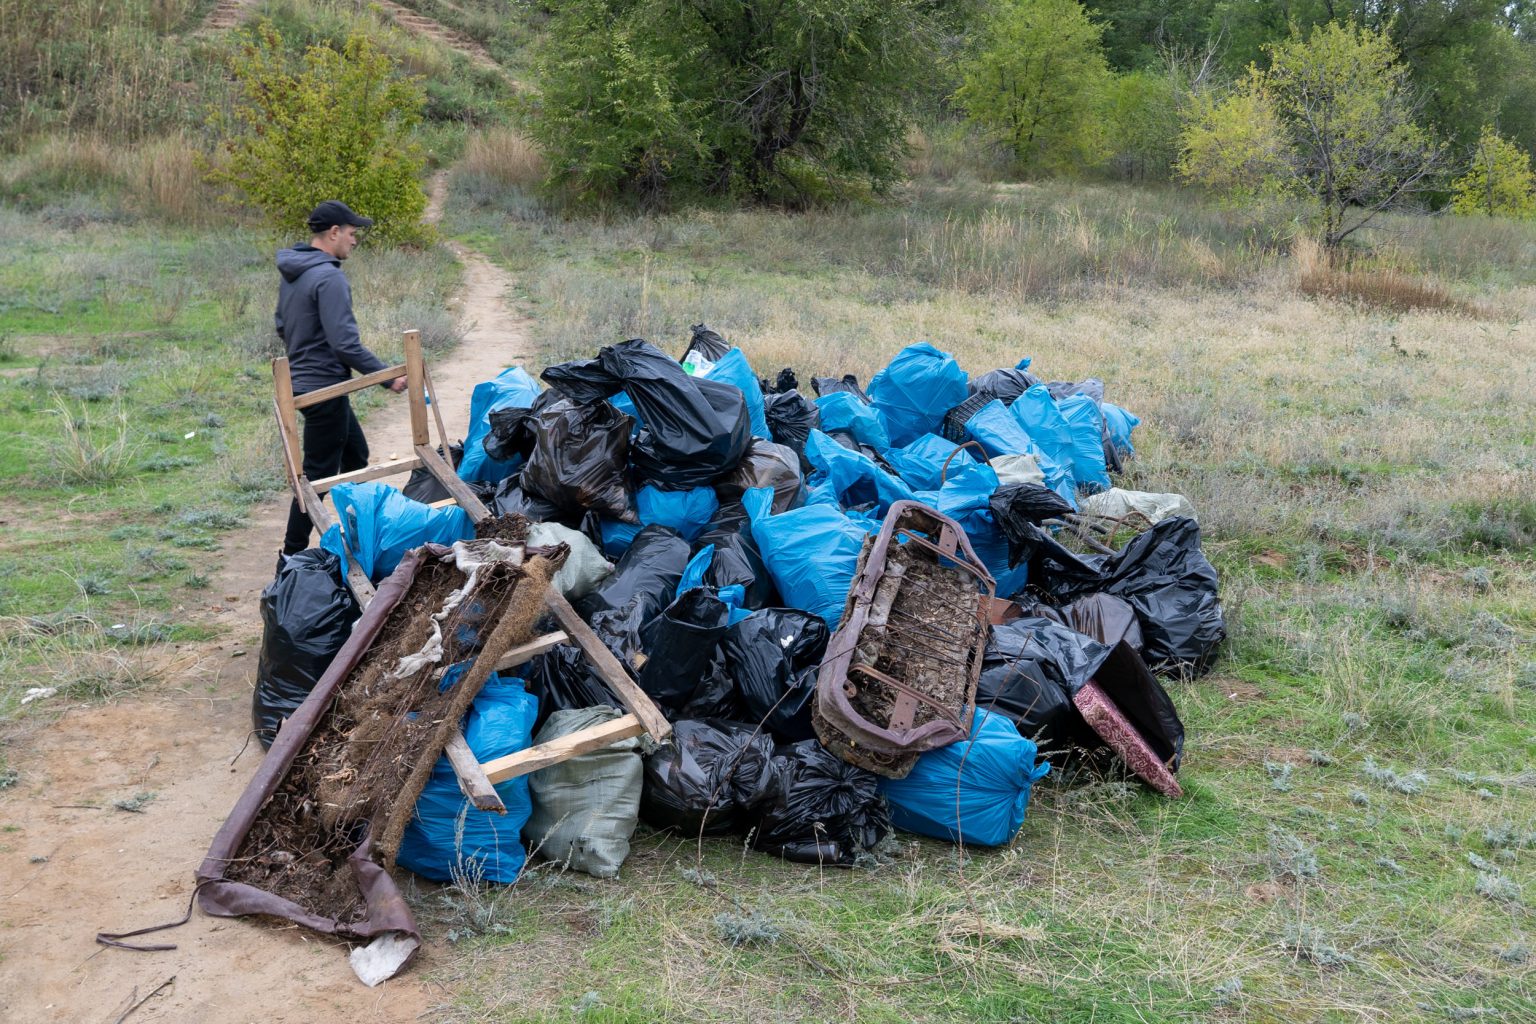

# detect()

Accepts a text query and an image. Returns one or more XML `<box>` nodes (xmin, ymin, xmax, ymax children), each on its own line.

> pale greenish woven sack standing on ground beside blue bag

<box><xmin>522</xmin><ymin>706</ymin><xmax>642</xmax><ymax>878</ymax></box>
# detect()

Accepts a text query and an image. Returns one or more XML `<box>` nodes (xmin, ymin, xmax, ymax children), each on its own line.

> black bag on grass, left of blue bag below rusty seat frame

<box><xmin>753</xmin><ymin>740</ymin><xmax>891</xmax><ymax>867</ymax></box>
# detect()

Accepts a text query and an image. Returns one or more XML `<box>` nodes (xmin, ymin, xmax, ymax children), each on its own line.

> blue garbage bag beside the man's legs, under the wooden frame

<box><xmin>319</xmin><ymin>481</ymin><xmax>475</xmax><ymax>583</ymax></box>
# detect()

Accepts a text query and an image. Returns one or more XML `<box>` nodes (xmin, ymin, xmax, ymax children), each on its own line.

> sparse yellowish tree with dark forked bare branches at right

<box><xmin>1180</xmin><ymin>23</ymin><xmax>1444</xmax><ymax>249</ymax></box>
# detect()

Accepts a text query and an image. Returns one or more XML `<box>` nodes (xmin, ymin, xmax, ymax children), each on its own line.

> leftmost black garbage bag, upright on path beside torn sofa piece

<box><xmin>250</xmin><ymin>548</ymin><xmax>362</xmax><ymax>749</ymax></box>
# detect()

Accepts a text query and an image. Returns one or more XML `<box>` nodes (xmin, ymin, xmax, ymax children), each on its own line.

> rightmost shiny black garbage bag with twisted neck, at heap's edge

<box><xmin>1031</xmin><ymin>516</ymin><xmax>1227</xmax><ymax>676</ymax></box>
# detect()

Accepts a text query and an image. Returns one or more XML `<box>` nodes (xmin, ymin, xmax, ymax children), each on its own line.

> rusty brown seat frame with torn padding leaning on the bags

<box><xmin>811</xmin><ymin>500</ymin><xmax>994</xmax><ymax>778</ymax></box>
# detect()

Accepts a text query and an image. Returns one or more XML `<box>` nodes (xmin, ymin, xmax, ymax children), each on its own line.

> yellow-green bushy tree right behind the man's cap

<box><xmin>209</xmin><ymin>21</ymin><xmax>430</xmax><ymax>243</ymax></box>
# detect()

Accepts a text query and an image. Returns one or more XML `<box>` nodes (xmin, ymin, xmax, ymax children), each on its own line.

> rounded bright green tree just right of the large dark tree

<box><xmin>955</xmin><ymin>0</ymin><xmax>1111</xmax><ymax>172</ymax></box>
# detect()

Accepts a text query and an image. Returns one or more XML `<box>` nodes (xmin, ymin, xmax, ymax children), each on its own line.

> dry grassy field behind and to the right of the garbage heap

<box><xmin>416</xmin><ymin>173</ymin><xmax>1536</xmax><ymax>1024</ymax></box>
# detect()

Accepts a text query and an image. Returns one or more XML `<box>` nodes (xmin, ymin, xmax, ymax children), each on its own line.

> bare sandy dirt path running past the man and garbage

<box><xmin>0</xmin><ymin>178</ymin><xmax>531</xmax><ymax>1024</ymax></box>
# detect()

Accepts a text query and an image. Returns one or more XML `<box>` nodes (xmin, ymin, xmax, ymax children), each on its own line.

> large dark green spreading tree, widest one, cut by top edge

<box><xmin>533</xmin><ymin>0</ymin><xmax>943</xmax><ymax>203</ymax></box>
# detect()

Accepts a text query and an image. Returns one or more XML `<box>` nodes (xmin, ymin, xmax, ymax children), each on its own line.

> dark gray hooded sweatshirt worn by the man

<box><xmin>276</xmin><ymin>246</ymin><xmax>389</xmax><ymax>395</ymax></box>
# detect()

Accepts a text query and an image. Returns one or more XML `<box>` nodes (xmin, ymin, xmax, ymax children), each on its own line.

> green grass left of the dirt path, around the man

<box><xmin>0</xmin><ymin>210</ymin><xmax>458</xmax><ymax>722</ymax></box>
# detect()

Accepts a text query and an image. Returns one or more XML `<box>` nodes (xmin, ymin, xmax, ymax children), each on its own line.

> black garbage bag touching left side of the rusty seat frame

<box><xmin>720</xmin><ymin>608</ymin><xmax>831</xmax><ymax>743</ymax></box>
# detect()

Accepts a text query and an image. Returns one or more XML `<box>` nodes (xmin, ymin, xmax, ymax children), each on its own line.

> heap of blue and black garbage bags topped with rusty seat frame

<box><xmin>253</xmin><ymin>325</ymin><xmax>1226</xmax><ymax>881</ymax></box>
